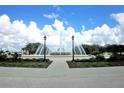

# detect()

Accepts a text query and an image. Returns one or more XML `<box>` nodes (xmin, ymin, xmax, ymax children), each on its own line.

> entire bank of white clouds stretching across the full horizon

<box><xmin>0</xmin><ymin>13</ymin><xmax>124</xmax><ymax>51</ymax></box>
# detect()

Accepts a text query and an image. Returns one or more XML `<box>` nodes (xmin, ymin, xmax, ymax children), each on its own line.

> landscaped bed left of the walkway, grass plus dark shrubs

<box><xmin>0</xmin><ymin>51</ymin><xmax>52</xmax><ymax>68</ymax></box>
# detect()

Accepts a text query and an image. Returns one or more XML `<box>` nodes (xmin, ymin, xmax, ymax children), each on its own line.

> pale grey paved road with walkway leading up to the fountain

<box><xmin>0</xmin><ymin>57</ymin><xmax>124</xmax><ymax>88</ymax></box>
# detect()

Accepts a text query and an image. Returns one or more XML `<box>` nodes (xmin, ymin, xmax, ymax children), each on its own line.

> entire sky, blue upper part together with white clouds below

<box><xmin>0</xmin><ymin>5</ymin><xmax>124</xmax><ymax>51</ymax></box>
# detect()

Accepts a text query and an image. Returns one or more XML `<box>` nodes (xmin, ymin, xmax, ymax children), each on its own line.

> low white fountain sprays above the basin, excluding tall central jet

<box><xmin>35</xmin><ymin>44</ymin><xmax>86</xmax><ymax>55</ymax></box>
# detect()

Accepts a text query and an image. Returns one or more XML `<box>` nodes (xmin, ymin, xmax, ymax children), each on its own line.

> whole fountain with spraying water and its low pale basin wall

<box><xmin>22</xmin><ymin>31</ymin><xmax>91</xmax><ymax>59</ymax></box>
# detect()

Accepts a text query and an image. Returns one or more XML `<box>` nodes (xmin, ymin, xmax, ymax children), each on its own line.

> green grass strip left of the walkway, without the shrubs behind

<box><xmin>0</xmin><ymin>61</ymin><xmax>52</xmax><ymax>68</ymax></box>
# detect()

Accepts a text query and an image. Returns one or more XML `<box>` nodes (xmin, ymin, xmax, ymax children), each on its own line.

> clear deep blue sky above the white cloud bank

<box><xmin>0</xmin><ymin>5</ymin><xmax>124</xmax><ymax>31</ymax></box>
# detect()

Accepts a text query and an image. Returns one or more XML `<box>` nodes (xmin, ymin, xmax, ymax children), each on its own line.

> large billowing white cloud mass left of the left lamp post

<box><xmin>0</xmin><ymin>15</ymin><xmax>41</xmax><ymax>51</ymax></box>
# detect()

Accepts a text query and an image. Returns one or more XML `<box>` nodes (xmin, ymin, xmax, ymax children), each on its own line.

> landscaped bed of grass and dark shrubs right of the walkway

<box><xmin>67</xmin><ymin>56</ymin><xmax>124</xmax><ymax>68</ymax></box>
